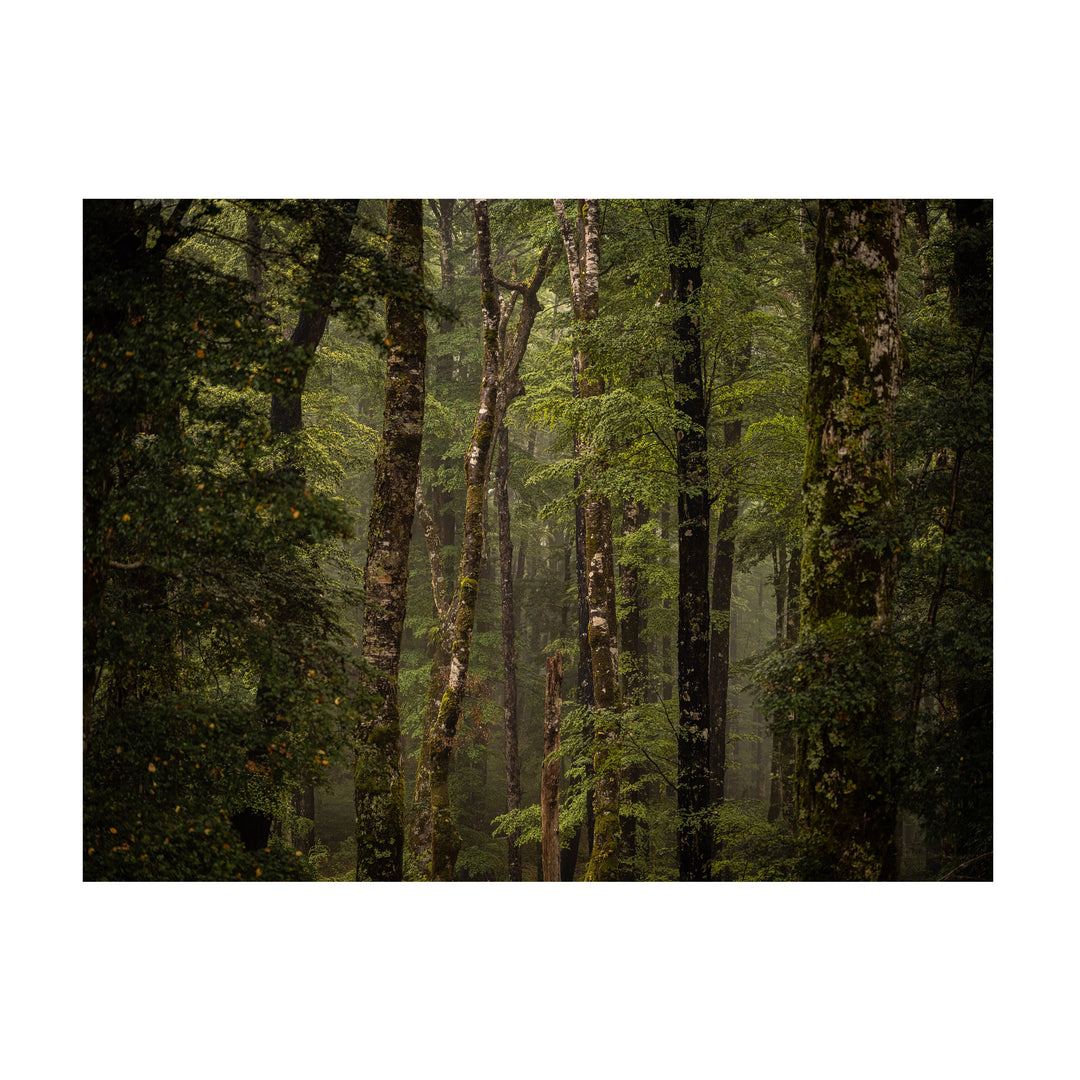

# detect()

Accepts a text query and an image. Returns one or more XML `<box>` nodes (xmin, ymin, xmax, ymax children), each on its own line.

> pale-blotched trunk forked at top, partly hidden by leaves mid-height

<box><xmin>554</xmin><ymin>199</ymin><xmax>622</xmax><ymax>881</ymax></box>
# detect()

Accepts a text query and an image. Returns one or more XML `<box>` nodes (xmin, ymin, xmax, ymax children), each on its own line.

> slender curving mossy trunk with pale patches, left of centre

<box><xmin>430</xmin><ymin>199</ymin><xmax>501</xmax><ymax>881</ymax></box>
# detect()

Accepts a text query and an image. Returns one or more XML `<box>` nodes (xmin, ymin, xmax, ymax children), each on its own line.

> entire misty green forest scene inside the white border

<box><xmin>82</xmin><ymin>198</ymin><xmax>994</xmax><ymax>882</ymax></box>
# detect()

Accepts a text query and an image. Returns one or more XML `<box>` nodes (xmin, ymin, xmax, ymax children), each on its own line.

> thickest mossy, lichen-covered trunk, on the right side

<box><xmin>796</xmin><ymin>200</ymin><xmax>904</xmax><ymax>880</ymax></box>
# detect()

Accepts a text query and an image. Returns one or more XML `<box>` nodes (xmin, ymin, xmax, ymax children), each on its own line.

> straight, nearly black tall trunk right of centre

<box><xmin>667</xmin><ymin>200</ymin><xmax>712</xmax><ymax>881</ymax></box>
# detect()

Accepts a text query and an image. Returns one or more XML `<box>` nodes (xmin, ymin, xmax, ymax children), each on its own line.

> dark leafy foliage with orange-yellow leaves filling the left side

<box><xmin>83</xmin><ymin>202</ymin><xmax>406</xmax><ymax>879</ymax></box>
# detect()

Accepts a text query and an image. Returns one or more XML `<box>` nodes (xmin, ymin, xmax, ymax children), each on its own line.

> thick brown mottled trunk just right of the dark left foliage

<box><xmin>355</xmin><ymin>199</ymin><xmax>428</xmax><ymax>881</ymax></box>
